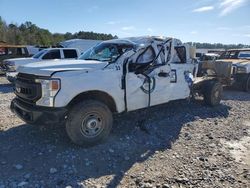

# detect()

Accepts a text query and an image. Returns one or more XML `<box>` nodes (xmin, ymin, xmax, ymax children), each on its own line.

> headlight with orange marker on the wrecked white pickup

<box><xmin>35</xmin><ymin>79</ymin><xmax>61</xmax><ymax>107</ymax></box>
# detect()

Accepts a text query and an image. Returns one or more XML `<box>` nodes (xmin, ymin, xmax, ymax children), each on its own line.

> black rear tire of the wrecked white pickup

<box><xmin>203</xmin><ymin>81</ymin><xmax>223</xmax><ymax>106</ymax></box>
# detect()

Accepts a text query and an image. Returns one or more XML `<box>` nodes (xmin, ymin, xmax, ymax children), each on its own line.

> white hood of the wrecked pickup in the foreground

<box><xmin>17</xmin><ymin>60</ymin><xmax>107</xmax><ymax>76</ymax></box>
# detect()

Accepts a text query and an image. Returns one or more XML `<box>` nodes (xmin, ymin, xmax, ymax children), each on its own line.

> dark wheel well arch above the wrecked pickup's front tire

<box><xmin>68</xmin><ymin>91</ymin><xmax>117</xmax><ymax>112</ymax></box>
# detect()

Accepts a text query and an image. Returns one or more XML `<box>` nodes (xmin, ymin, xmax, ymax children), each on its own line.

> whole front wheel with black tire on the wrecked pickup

<box><xmin>66</xmin><ymin>100</ymin><xmax>113</xmax><ymax>146</ymax></box>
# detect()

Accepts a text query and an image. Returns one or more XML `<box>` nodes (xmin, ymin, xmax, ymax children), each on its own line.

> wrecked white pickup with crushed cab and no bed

<box><xmin>11</xmin><ymin>37</ymin><xmax>222</xmax><ymax>146</ymax></box>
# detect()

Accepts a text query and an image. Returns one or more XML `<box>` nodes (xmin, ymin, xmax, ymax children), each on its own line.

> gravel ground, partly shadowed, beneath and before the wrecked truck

<box><xmin>0</xmin><ymin>77</ymin><xmax>250</xmax><ymax>188</ymax></box>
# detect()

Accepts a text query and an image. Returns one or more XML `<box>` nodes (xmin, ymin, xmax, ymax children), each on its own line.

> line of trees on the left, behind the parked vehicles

<box><xmin>0</xmin><ymin>16</ymin><xmax>118</xmax><ymax>46</ymax></box>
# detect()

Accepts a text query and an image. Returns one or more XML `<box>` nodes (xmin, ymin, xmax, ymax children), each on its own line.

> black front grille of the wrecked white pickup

<box><xmin>15</xmin><ymin>73</ymin><xmax>42</xmax><ymax>103</ymax></box>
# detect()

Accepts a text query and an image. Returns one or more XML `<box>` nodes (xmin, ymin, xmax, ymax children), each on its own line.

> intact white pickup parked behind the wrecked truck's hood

<box><xmin>1</xmin><ymin>48</ymin><xmax>80</xmax><ymax>82</ymax></box>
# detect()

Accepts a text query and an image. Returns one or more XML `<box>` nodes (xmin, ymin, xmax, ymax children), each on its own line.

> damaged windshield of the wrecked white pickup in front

<box><xmin>79</xmin><ymin>42</ymin><xmax>133</xmax><ymax>62</ymax></box>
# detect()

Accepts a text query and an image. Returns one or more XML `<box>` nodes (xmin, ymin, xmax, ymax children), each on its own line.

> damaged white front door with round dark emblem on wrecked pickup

<box><xmin>126</xmin><ymin>48</ymin><xmax>171</xmax><ymax>111</ymax></box>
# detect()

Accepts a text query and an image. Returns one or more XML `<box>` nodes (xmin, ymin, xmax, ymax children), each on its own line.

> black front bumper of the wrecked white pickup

<box><xmin>10</xmin><ymin>98</ymin><xmax>67</xmax><ymax>124</ymax></box>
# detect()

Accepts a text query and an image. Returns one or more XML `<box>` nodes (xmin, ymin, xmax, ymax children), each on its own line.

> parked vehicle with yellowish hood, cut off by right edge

<box><xmin>217</xmin><ymin>48</ymin><xmax>250</xmax><ymax>92</ymax></box>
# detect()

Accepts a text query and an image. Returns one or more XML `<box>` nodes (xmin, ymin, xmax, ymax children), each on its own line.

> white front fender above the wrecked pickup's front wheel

<box><xmin>53</xmin><ymin>69</ymin><xmax>125</xmax><ymax>112</ymax></box>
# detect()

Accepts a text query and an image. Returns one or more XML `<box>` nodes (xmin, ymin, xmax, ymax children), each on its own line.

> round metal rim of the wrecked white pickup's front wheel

<box><xmin>81</xmin><ymin>112</ymin><xmax>103</xmax><ymax>138</ymax></box>
